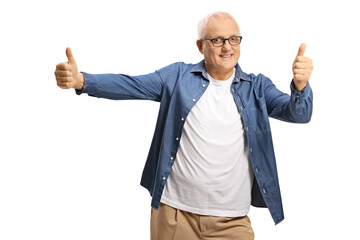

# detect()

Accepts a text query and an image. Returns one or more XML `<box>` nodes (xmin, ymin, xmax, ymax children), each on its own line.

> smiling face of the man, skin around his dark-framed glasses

<box><xmin>197</xmin><ymin>17</ymin><xmax>240</xmax><ymax>80</ymax></box>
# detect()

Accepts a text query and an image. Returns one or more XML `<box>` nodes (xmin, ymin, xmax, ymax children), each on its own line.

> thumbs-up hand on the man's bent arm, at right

<box><xmin>293</xmin><ymin>43</ymin><xmax>313</xmax><ymax>91</ymax></box>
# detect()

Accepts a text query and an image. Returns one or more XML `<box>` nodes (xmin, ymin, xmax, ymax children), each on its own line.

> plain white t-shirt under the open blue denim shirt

<box><xmin>161</xmin><ymin>71</ymin><xmax>253</xmax><ymax>217</ymax></box>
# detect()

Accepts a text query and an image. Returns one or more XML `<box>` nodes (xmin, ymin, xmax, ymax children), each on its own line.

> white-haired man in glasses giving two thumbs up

<box><xmin>55</xmin><ymin>12</ymin><xmax>313</xmax><ymax>240</ymax></box>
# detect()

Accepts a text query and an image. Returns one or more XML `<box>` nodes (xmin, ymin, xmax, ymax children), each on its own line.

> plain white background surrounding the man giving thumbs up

<box><xmin>0</xmin><ymin>0</ymin><xmax>360</xmax><ymax>240</ymax></box>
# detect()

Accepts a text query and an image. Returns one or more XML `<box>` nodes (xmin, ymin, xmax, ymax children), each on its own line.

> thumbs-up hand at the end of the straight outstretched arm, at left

<box><xmin>54</xmin><ymin>48</ymin><xmax>84</xmax><ymax>90</ymax></box>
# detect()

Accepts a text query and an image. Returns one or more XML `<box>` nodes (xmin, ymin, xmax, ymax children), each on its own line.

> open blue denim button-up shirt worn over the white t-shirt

<box><xmin>76</xmin><ymin>60</ymin><xmax>313</xmax><ymax>224</ymax></box>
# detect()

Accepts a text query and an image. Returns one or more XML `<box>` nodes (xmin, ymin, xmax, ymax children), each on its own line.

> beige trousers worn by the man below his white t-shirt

<box><xmin>150</xmin><ymin>203</ymin><xmax>254</xmax><ymax>240</ymax></box>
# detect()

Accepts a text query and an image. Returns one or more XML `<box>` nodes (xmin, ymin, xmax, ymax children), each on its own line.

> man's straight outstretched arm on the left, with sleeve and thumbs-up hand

<box><xmin>55</xmin><ymin>48</ymin><xmax>169</xmax><ymax>101</ymax></box>
